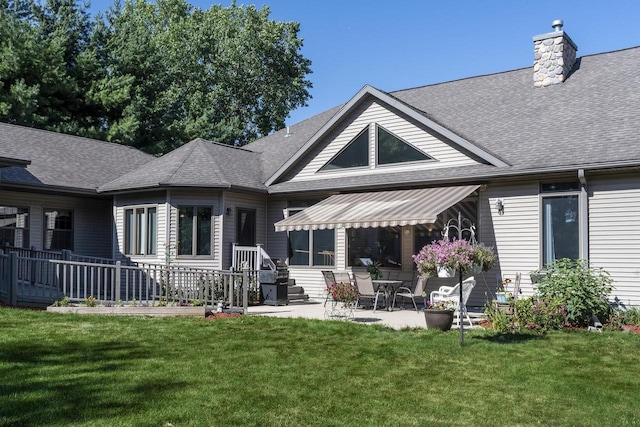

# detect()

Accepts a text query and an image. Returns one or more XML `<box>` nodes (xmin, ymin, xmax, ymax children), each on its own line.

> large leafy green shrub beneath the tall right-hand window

<box><xmin>533</xmin><ymin>258</ymin><xmax>612</xmax><ymax>326</ymax></box>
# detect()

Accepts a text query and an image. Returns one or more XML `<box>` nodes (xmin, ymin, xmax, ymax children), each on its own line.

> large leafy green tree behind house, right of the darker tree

<box><xmin>97</xmin><ymin>0</ymin><xmax>311</xmax><ymax>153</ymax></box>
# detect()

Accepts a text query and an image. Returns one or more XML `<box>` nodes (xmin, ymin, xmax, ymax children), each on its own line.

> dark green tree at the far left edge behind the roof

<box><xmin>0</xmin><ymin>0</ymin><xmax>99</xmax><ymax>136</ymax></box>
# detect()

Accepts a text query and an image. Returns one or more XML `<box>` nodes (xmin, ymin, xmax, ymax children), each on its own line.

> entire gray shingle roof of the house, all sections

<box><xmin>0</xmin><ymin>47</ymin><xmax>640</xmax><ymax>193</ymax></box>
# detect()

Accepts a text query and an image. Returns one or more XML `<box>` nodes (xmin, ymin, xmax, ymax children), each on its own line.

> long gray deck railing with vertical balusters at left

<box><xmin>0</xmin><ymin>252</ymin><xmax>259</xmax><ymax>310</ymax></box>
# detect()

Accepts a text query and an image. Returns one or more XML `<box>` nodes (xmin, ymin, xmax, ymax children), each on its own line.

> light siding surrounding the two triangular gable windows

<box><xmin>291</xmin><ymin>101</ymin><xmax>477</xmax><ymax>181</ymax></box>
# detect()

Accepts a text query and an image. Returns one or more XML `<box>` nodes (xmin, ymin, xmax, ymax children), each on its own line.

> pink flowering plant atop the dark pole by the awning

<box><xmin>413</xmin><ymin>239</ymin><xmax>496</xmax><ymax>279</ymax></box>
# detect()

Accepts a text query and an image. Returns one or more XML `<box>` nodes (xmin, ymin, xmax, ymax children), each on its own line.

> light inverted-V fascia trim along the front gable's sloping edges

<box><xmin>265</xmin><ymin>85</ymin><xmax>509</xmax><ymax>186</ymax></box>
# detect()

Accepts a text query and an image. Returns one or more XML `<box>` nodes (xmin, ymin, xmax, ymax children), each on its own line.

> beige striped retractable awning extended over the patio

<box><xmin>275</xmin><ymin>185</ymin><xmax>480</xmax><ymax>231</ymax></box>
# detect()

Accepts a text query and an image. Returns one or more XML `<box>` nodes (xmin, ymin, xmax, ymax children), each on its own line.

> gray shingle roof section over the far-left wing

<box><xmin>0</xmin><ymin>123</ymin><xmax>154</xmax><ymax>192</ymax></box>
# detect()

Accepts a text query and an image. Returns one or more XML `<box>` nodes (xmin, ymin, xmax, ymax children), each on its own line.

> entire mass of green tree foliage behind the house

<box><xmin>0</xmin><ymin>0</ymin><xmax>311</xmax><ymax>154</ymax></box>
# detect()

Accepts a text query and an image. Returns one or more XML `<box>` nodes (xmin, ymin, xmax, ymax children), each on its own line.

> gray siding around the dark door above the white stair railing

<box><xmin>222</xmin><ymin>192</ymin><xmax>273</xmax><ymax>269</ymax></box>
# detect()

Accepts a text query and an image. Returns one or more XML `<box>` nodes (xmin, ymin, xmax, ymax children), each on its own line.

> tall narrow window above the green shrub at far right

<box><xmin>542</xmin><ymin>183</ymin><xmax>581</xmax><ymax>265</ymax></box>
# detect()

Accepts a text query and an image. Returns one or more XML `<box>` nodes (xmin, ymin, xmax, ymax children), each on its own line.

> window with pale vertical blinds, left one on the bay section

<box><xmin>124</xmin><ymin>207</ymin><xmax>158</xmax><ymax>255</ymax></box>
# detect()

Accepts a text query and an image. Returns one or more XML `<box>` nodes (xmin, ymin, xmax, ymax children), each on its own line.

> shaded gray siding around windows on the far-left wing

<box><xmin>0</xmin><ymin>191</ymin><xmax>112</xmax><ymax>258</ymax></box>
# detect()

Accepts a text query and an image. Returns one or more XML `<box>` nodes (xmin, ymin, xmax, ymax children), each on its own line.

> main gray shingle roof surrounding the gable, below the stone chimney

<box><xmin>258</xmin><ymin>47</ymin><xmax>640</xmax><ymax>192</ymax></box>
